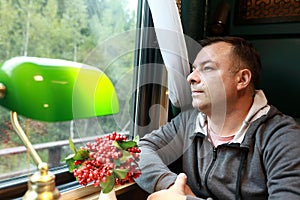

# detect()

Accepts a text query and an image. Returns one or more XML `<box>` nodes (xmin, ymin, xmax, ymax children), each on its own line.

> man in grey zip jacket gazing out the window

<box><xmin>136</xmin><ymin>37</ymin><xmax>300</xmax><ymax>200</ymax></box>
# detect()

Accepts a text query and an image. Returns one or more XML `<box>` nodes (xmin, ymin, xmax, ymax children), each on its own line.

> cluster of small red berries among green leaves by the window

<box><xmin>73</xmin><ymin>132</ymin><xmax>141</xmax><ymax>187</ymax></box>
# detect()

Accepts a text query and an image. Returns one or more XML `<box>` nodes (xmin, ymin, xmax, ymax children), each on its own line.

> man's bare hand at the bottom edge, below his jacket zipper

<box><xmin>147</xmin><ymin>173</ymin><xmax>195</xmax><ymax>200</ymax></box>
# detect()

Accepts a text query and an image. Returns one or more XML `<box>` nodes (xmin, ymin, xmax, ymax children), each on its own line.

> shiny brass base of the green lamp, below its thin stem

<box><xmin>23</xmin><ymin>162</ymin><xmax>60</xmax><ymax>200</ymax></box>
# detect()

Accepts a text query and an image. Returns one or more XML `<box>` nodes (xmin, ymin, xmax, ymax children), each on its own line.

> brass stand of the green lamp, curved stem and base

<box><xmin>11</xmin><ymin>112</ymin><xmax>60</xmax><ymax>200</ymax></box>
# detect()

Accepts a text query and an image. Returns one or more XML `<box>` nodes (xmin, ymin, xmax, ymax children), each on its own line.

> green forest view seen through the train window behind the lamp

<box><xmin>0</xmin><ymin>0</ymin><xmax>137</xmax><ymax>179</ymax></box>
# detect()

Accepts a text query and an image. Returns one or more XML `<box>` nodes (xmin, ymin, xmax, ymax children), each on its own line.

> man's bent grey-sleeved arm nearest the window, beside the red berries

<box><xmin>136</xmin><ymin>110</ymin><xmax>196</xmax><ymax>193</ymax></box>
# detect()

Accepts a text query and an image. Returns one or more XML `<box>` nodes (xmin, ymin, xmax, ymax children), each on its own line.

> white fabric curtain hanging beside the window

<box><xmin>148</xmin><ymin>0</ymin><xmax>192</xmax><ymax>108</ymax></box>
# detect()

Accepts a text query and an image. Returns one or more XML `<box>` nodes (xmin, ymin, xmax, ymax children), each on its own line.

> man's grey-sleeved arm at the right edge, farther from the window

<box><xmin>263</xmin><ymin>116</ymin><xmax>300</xmax><ymax>199</ymax></box>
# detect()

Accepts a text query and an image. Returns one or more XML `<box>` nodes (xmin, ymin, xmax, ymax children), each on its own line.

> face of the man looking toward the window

<box><xmin>187</xmin><ymin>42</ymin><xmax>236</xmax><ymax>115</ymax></box>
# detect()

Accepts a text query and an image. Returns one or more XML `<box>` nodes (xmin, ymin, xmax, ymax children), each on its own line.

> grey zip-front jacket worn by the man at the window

<box><xmin>136</xmin><ymin>106</ymin><xmax>300</xmax><ymax>200</ymax></box>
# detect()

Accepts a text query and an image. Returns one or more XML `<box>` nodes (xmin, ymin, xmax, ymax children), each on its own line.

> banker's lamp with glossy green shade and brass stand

<box><xmin>0</xmin><ymin>57</ymin><xmax>119</xmax><ymax>200</ymax></box>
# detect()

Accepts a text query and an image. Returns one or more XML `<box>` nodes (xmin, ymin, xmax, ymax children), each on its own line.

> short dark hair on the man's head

<box><xmin>200</xmin><ymin>36</ymin><xmax>262</xmax><ymax>88</ymax></box>
